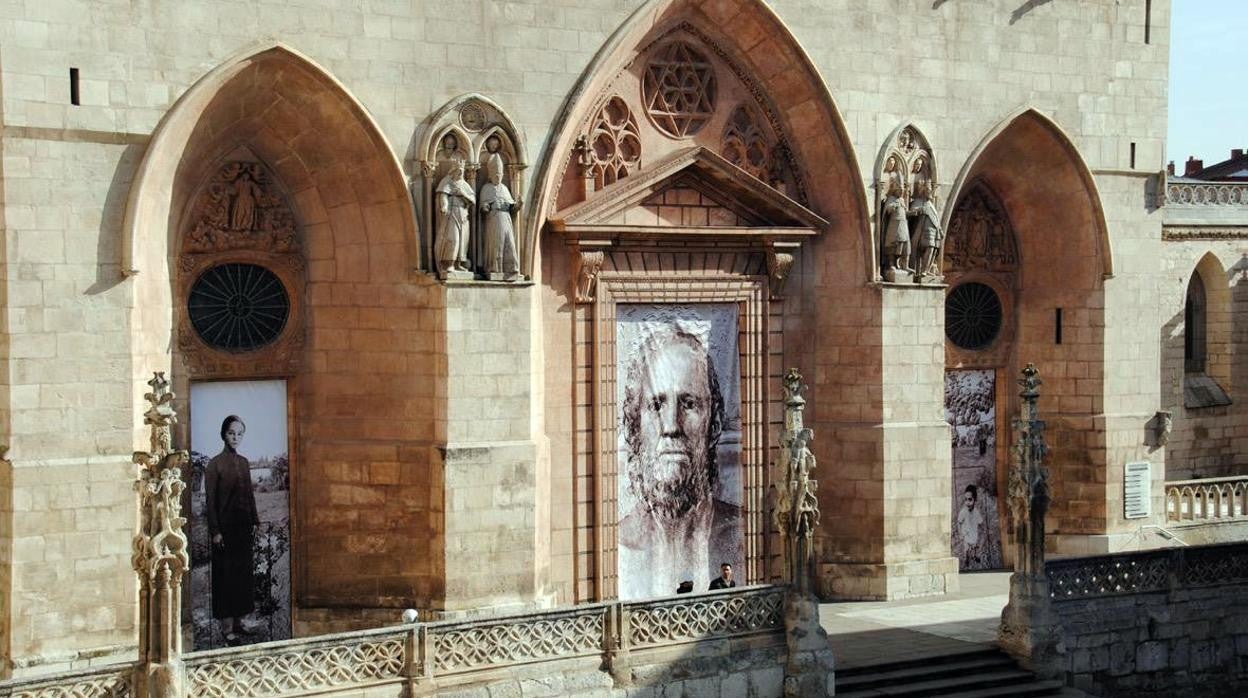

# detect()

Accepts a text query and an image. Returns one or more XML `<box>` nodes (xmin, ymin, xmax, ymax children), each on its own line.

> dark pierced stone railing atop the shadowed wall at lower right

<box><xmin>1045</xmin><ymin>543</ymin><xmax>1248</xmax><ymax>601</ymax></box>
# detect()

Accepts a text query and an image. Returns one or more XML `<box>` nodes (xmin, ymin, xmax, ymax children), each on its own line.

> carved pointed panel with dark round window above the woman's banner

<box><xmin>176</xmin><ymin>156</ymin><xmax>306</xmax><ymax>378</ymax></box>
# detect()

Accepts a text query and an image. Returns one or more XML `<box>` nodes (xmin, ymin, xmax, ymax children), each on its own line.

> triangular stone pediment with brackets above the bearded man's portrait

<box><xmin>549</xmin><ymin>146</ymin><xmax>827</xmax><ymax>302</ymax></box>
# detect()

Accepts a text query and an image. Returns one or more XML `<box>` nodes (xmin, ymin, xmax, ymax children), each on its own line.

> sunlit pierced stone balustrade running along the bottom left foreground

<box><xmin>0</xmin><ymin>586</ymin><xmax>785</xmax><ymax>698</ymax></box>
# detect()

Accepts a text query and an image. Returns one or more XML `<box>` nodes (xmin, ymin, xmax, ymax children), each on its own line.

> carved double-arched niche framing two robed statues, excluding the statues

<box><xmin>412</xmin><ymin>94</ymin><xmax>529</xmax><ymax>280</ymax></box>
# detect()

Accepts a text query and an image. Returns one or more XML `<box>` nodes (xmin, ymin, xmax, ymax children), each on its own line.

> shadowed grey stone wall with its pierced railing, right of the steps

<box><xmin>1047</xmin><ymin>543</ymin><xmax>1248</xmax><ymax>698</ymax></box>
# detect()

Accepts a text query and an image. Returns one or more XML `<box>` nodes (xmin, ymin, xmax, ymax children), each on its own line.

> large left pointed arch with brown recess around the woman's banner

<box><xmin>124</xmin><ymin>44</ymin><xmax>444</xmax><ymax>619</ymax></box>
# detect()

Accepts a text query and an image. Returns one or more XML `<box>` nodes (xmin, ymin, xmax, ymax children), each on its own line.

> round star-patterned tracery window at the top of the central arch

<box><xmin>641</xmin><ymin>41</ymin><xmax>715</xmax><ymax>139</ymax></box>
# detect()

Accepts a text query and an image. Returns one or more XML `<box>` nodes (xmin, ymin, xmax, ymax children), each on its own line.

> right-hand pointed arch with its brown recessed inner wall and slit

<box><xmin>943</xmin><ymin>107</ymin><xmax>1114</xmax><ymax>536</ymax></box>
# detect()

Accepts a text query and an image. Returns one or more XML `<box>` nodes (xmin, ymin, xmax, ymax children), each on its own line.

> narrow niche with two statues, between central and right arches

<box><xmin>875</xmin><ymin>126</ymin><xmax>945</xmax><ymax>283</ymax></box>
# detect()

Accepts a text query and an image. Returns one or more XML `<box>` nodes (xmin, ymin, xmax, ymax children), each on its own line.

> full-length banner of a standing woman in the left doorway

<box><xmin>191</xmin><ymin>381</ymin><xmax>291</xmax><ymax>649</ymax></box>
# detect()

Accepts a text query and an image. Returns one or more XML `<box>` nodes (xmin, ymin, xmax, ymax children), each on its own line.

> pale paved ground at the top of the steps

<box><xmin>819</xmin><ymin>572</ymin><xmax>1010</xmax><ymax>669</ymax></box>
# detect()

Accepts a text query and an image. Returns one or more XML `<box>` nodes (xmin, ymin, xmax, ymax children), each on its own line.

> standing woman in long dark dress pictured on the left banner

<box><xmin>203</xmin><ymin>415</ymin><xmax>260</xmax><ymax>646</ymax></box>
